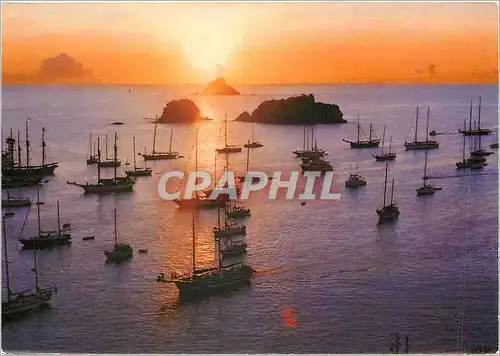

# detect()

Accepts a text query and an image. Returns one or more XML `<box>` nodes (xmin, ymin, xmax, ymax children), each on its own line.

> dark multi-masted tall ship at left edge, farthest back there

<box><xmin>2</xmin><ymin>123</ymin><xmax>58</xmax><ymax>176</ymax></box>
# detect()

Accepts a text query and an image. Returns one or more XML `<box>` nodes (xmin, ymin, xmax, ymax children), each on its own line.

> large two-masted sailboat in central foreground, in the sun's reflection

<box><xmin>156</xmin><ymin>212</ymin><xmax>255</xmax><ymax>299</ymax></box>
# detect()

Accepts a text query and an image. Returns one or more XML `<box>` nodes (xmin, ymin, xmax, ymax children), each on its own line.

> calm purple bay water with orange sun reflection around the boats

<box><xmin>2</xmin><ymin>86</ymin><xmax>498</xmax><ymax>353</ymax></box>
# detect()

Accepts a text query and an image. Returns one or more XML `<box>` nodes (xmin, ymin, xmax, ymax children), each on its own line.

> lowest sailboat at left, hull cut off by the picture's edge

<box><xmin>2</xmin><ymin>214</ymin><xmax>52</xmax><ymax>321</ymax></box>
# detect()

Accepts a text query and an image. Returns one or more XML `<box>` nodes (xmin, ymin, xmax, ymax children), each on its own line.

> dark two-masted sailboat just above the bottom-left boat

<box><xmin>19</xmin><ymin>188</ymin><xmax>71</xmax><ymax>249</ymax></box>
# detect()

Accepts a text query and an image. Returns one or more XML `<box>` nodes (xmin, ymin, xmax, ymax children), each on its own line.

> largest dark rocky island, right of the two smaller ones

<box><xmin>235</xmin><ymin>94</ymin><xmax>347</xmax><ymax>125</ymax></box>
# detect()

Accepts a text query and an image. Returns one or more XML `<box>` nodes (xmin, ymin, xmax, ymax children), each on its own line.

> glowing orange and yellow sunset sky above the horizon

<box><xmin>2</xmin><ymin>2</ymin><xmax>498</xmax><ymax>84</ymax></box>
